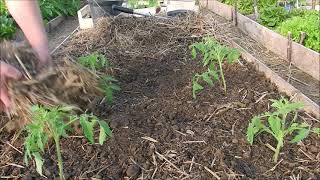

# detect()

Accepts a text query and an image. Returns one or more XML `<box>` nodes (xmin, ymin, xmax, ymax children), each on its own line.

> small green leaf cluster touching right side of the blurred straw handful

<box><xmin>100</xmin><ymin>76</ymin><xmax>121</xmax><ymax>104</ymax></box>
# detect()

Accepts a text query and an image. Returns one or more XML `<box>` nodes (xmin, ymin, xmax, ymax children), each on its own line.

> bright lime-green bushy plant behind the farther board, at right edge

<box><xmin>277</xmin><ymin>11</ymin><xmax>320</xmax><ymax>52</ymax></box>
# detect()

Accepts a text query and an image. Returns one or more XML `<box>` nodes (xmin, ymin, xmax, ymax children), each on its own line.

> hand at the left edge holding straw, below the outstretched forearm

<box><xmin>0</xmin><ymin>61</ymin><xmax>22</xmax><ymax>109</ymax></box>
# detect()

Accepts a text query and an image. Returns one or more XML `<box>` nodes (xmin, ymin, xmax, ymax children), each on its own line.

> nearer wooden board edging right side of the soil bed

<box><xmin>231</xmin><ymin>41</ymin><xmax>320</xmax><ymax>119</ymax></box>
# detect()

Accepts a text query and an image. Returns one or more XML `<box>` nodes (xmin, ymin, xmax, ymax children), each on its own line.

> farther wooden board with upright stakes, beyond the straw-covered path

<box><xmin>199</xmin><ymin>0</ymin><xmax>320</xmax><ymax>80</ymax></box>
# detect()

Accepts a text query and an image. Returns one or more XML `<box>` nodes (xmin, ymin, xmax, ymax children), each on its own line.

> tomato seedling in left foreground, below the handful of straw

<box><xmin>24</xmin><ymin>106</ymin><xmax>111</xmax><ymax>179</ymax></box>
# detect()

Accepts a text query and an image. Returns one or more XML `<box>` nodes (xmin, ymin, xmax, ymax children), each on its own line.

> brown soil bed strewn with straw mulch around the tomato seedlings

<box><xmin>0</xmin><ymin>17</ymin><xmax>320</xmax><ymax>179</ymax></box>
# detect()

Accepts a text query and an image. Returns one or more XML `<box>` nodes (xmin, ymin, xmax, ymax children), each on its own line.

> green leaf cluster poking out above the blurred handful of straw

<box><xmin>78</xmin><ymin>53</ymin><xmax>109</xmax><ymax>71</ymax></box>
